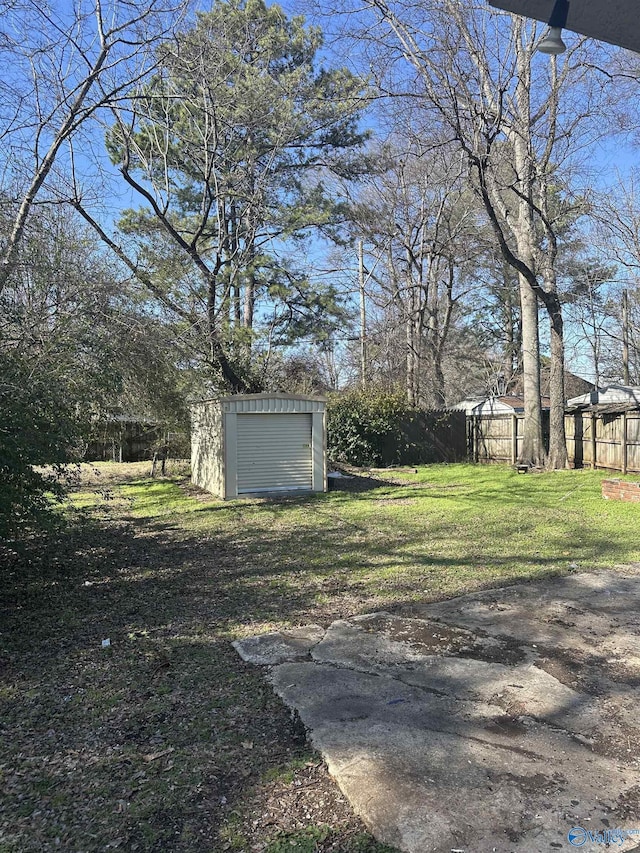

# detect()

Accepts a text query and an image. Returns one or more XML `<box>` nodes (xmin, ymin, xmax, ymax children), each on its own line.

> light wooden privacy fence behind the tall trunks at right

<box><xmin>467</xmin><ymin>411</ymin><xmax>640</xmax><ymax>474</ymax></box>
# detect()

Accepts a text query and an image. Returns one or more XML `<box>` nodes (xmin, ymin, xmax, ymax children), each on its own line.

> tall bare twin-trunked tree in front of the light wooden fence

<box><xmin>330</xmin><ymin>0</ymin><xmax>608</xmax><ymax>467</ymax></box>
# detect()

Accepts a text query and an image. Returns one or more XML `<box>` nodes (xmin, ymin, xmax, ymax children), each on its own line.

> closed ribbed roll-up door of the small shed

<box><xmin>237</xmin><ymin>413</ymin><xmax>312</xmax><ymax>495</ymax></box>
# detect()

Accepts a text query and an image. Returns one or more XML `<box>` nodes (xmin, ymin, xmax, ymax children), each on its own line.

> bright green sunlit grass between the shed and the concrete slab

<box><xmin>76</xmin><ymin>465</ymin><xmax>640</xmax><ymax>632</ymax></box>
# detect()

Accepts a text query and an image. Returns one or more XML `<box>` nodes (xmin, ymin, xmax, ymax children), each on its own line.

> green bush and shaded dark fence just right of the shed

<box><xmin>327</xmin><ymin>391</ymin><xmax>467</xmax><ymax>467</ymax></box>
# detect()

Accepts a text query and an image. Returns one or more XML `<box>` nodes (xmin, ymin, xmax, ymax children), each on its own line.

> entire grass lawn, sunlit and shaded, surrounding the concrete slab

<box><xmin>0</xmin><ymin>464</ymin><xmax>640</xmax><ymax>853</ymax></box>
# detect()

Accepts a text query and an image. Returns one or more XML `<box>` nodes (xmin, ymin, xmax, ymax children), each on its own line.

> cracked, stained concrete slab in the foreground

<box><xmin>234</xmin><ymin>569</ymin><xmax>640</xmax><ymax>853</ymax></box>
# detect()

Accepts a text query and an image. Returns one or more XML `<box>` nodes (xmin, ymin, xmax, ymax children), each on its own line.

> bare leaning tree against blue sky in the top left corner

<box><xmin>0</xmin><ymin>0</ymin><xmax>183</xmax><ymax>293</ymax></box>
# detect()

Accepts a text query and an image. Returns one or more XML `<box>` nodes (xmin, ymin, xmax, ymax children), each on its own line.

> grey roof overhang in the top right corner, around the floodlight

<box><xmin>489</xmin><ymin>0</ymin><xmax>640</xmax><ymax>53</ymax></box>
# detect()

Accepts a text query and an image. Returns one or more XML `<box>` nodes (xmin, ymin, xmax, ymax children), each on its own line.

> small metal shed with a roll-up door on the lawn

<box><xmin>191</xmin><ymin>394</ymin><xmax>327</xmax><ymax>498</ymax></box>
